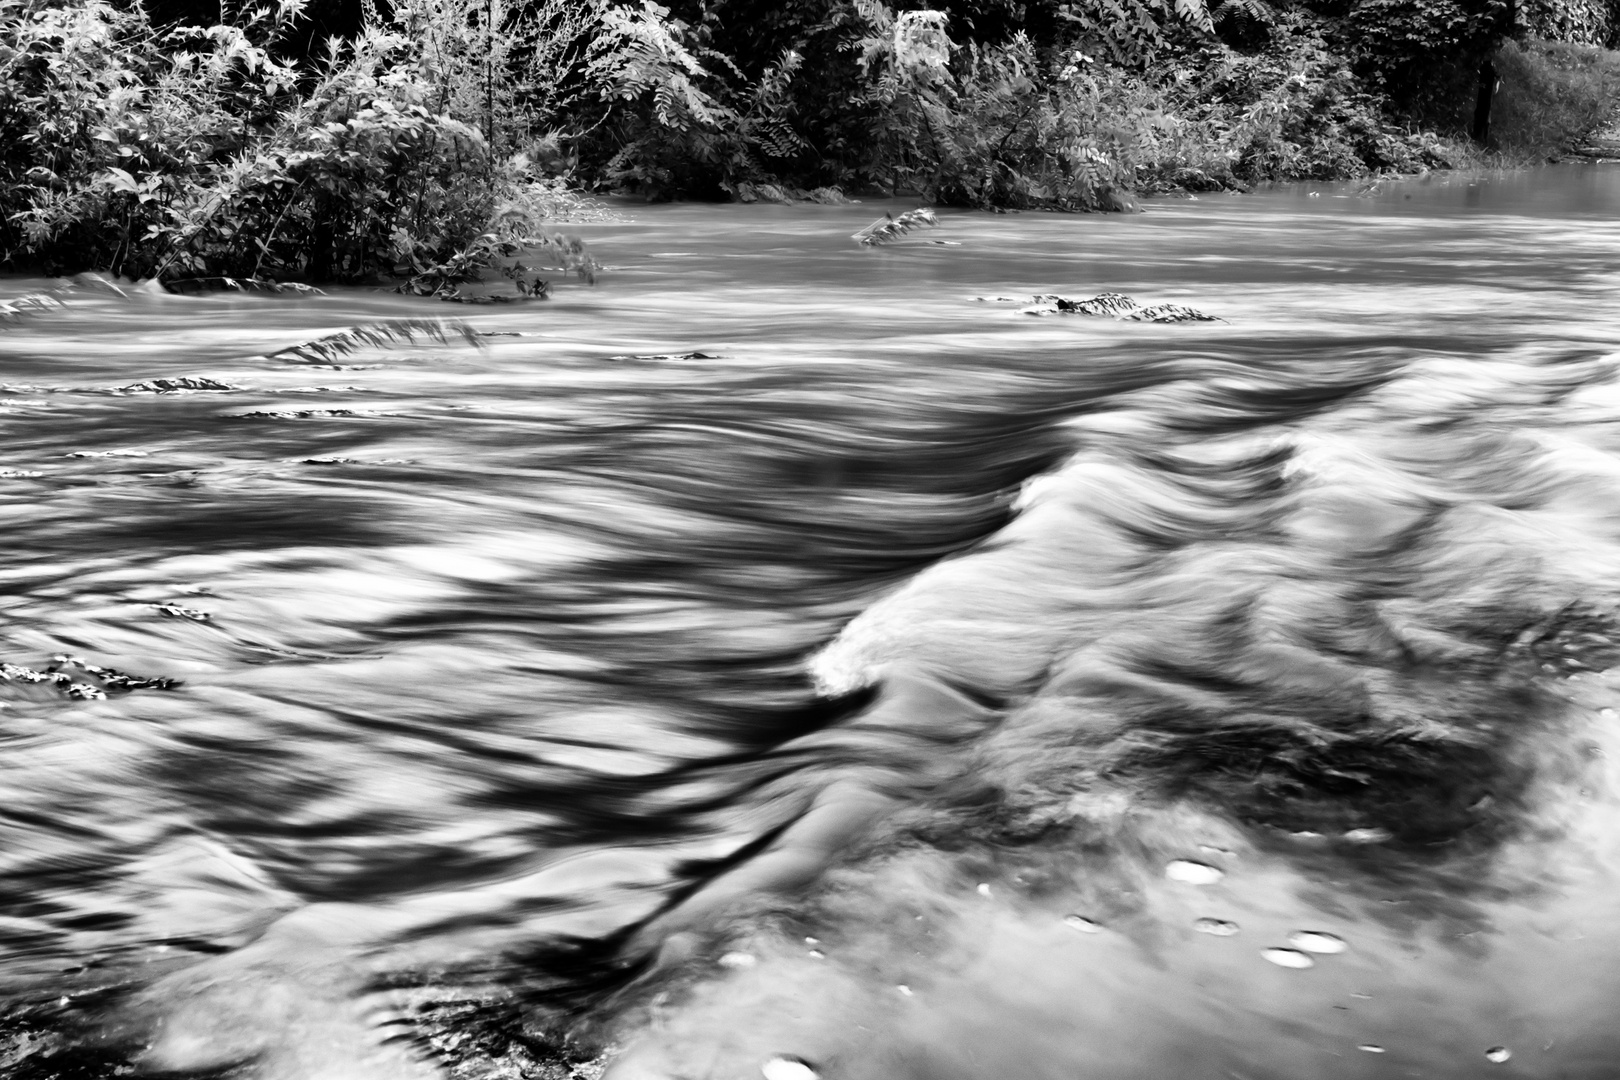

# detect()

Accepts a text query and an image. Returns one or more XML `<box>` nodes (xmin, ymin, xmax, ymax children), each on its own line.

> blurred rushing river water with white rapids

<box><xmin>0</xmin><ymin>165</ymin><xmax>1620</xmax><ymax>1080</ymax></box>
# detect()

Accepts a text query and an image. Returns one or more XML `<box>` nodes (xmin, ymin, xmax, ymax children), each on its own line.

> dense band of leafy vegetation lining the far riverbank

<box><xmin>0</xmin><ymin>0</ymin><xmax>1615</xmax><ymax>284</ymax></box>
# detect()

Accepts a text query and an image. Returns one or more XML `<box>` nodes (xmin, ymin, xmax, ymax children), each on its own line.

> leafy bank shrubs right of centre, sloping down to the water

<box><xmin>835</xmin><ymin>10</ymin><xmax>1443</xmax><ymax>209</ymax></box>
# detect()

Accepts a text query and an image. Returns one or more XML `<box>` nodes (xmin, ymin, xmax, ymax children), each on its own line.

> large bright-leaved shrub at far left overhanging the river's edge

<box><xmin>0</xmin><ymin>0</ymin><xmax>609</xmax><ymax>282</ymax></box>
